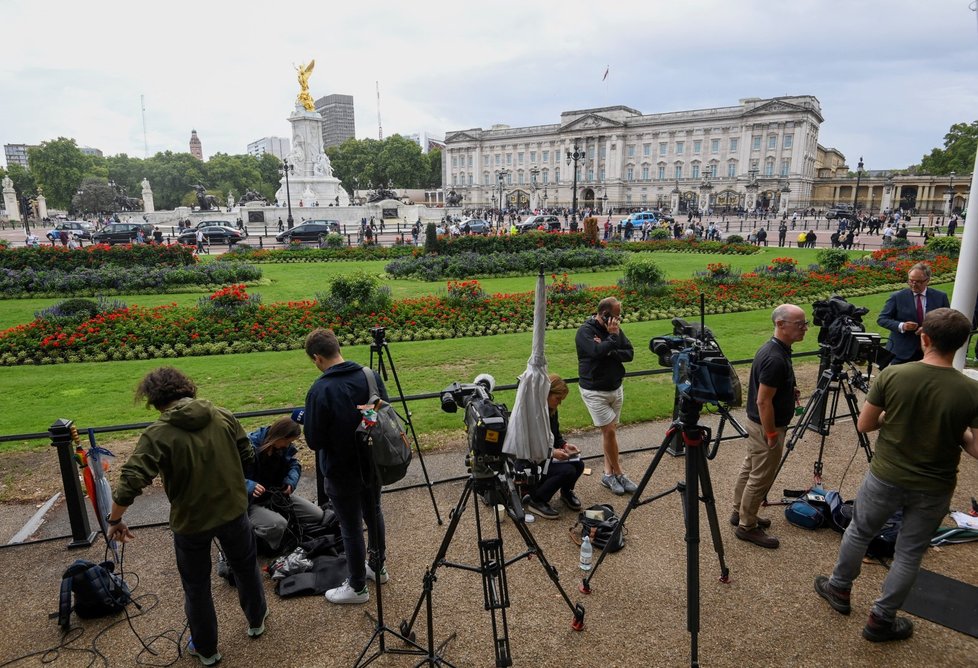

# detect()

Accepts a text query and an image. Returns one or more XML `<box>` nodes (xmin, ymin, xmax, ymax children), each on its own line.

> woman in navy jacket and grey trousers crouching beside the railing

<box><xmin>244</xmin><ymin>411</ymin><xmax>323</xmax><ymax>553</ymax></box>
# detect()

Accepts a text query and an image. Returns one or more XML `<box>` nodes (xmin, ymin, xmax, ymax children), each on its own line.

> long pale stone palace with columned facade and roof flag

<box><xmin>442</xmin><ymin>95</ymin><xmax>824</xmax><ymax>212</ymax></box>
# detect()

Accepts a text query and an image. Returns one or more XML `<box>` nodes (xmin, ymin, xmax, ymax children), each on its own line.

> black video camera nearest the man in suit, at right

<box><xmin>812</xmin><ymin>295</ymin><xmax>892</xmax><ymax>369</ymax></box>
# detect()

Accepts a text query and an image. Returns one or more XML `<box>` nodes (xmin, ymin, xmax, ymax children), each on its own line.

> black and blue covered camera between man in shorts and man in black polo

<box><xmin>649</xmin><ymin>318</ymin><xmax>740</xmax><ymax>405</ymax></box>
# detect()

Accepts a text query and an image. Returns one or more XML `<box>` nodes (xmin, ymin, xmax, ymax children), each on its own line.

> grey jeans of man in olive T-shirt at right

<box><xmin>829</xmin><ymin>472</ymin><xmax>953</xmax><ymax>622</ymax></box>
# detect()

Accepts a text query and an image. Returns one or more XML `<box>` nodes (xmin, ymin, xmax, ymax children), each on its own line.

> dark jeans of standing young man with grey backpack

<box><xmin>329</xmin><ymin>486</ymin><xmax>387</xmax><ymax>591</ymax></box>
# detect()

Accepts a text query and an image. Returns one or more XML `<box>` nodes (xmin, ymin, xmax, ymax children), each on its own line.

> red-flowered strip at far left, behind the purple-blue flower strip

<box><xmin>0</xmin><ymin>244</ymin><xmax>197</xmax><ymax>271</ymax></box>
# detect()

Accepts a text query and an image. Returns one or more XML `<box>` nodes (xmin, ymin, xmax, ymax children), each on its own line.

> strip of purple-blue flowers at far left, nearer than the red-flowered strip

<box><xmin>0</xmin><ymin>262</ymin><xmax>261</xmax><ymax>297</ymax></box>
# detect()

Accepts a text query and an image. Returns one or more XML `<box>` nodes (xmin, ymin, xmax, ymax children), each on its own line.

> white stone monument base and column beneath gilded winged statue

<box><xmin>275</xmin><ymin>104</ymin><xmax>350</xmax><ymax>207</ymax></box>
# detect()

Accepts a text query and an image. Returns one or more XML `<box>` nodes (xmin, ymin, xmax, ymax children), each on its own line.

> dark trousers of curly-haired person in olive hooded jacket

<box><xmin>173</xmin><ymin>513</ymin><xmax>268</xmax><ymax>656</ymax></box>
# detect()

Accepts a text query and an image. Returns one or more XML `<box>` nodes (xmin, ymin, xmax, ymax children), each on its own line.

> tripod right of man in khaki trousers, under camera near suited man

<box><xmin>774</xmin><ymin>346</ymin><xmax>873</xmax><ymax>483</ymax></box>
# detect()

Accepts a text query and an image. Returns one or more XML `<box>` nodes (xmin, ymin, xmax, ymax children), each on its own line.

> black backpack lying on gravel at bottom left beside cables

<box><xmin>58</xmin><ymin>559</ymin><xmax>132</xmax><ymax>629</ymax></box>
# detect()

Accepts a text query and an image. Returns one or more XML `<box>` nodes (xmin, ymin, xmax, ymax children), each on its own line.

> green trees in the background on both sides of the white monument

<box><xmin>0</xmin><ymin>135</ymin><xmax>441</xmax><ymax>213</ymax></box>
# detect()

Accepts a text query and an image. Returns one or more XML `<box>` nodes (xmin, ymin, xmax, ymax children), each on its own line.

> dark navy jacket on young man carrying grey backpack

<box><xmin>303</xmin><ymin>362</ymin><xmax>387</xmax><ymax>495</ymax></box>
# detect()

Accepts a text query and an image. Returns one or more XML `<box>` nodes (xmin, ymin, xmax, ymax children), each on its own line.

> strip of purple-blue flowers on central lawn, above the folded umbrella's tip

<box><xmin>384</xmin><ymin>248</ymin><xmax>625</xmax><ymax>281</ymax></box>
